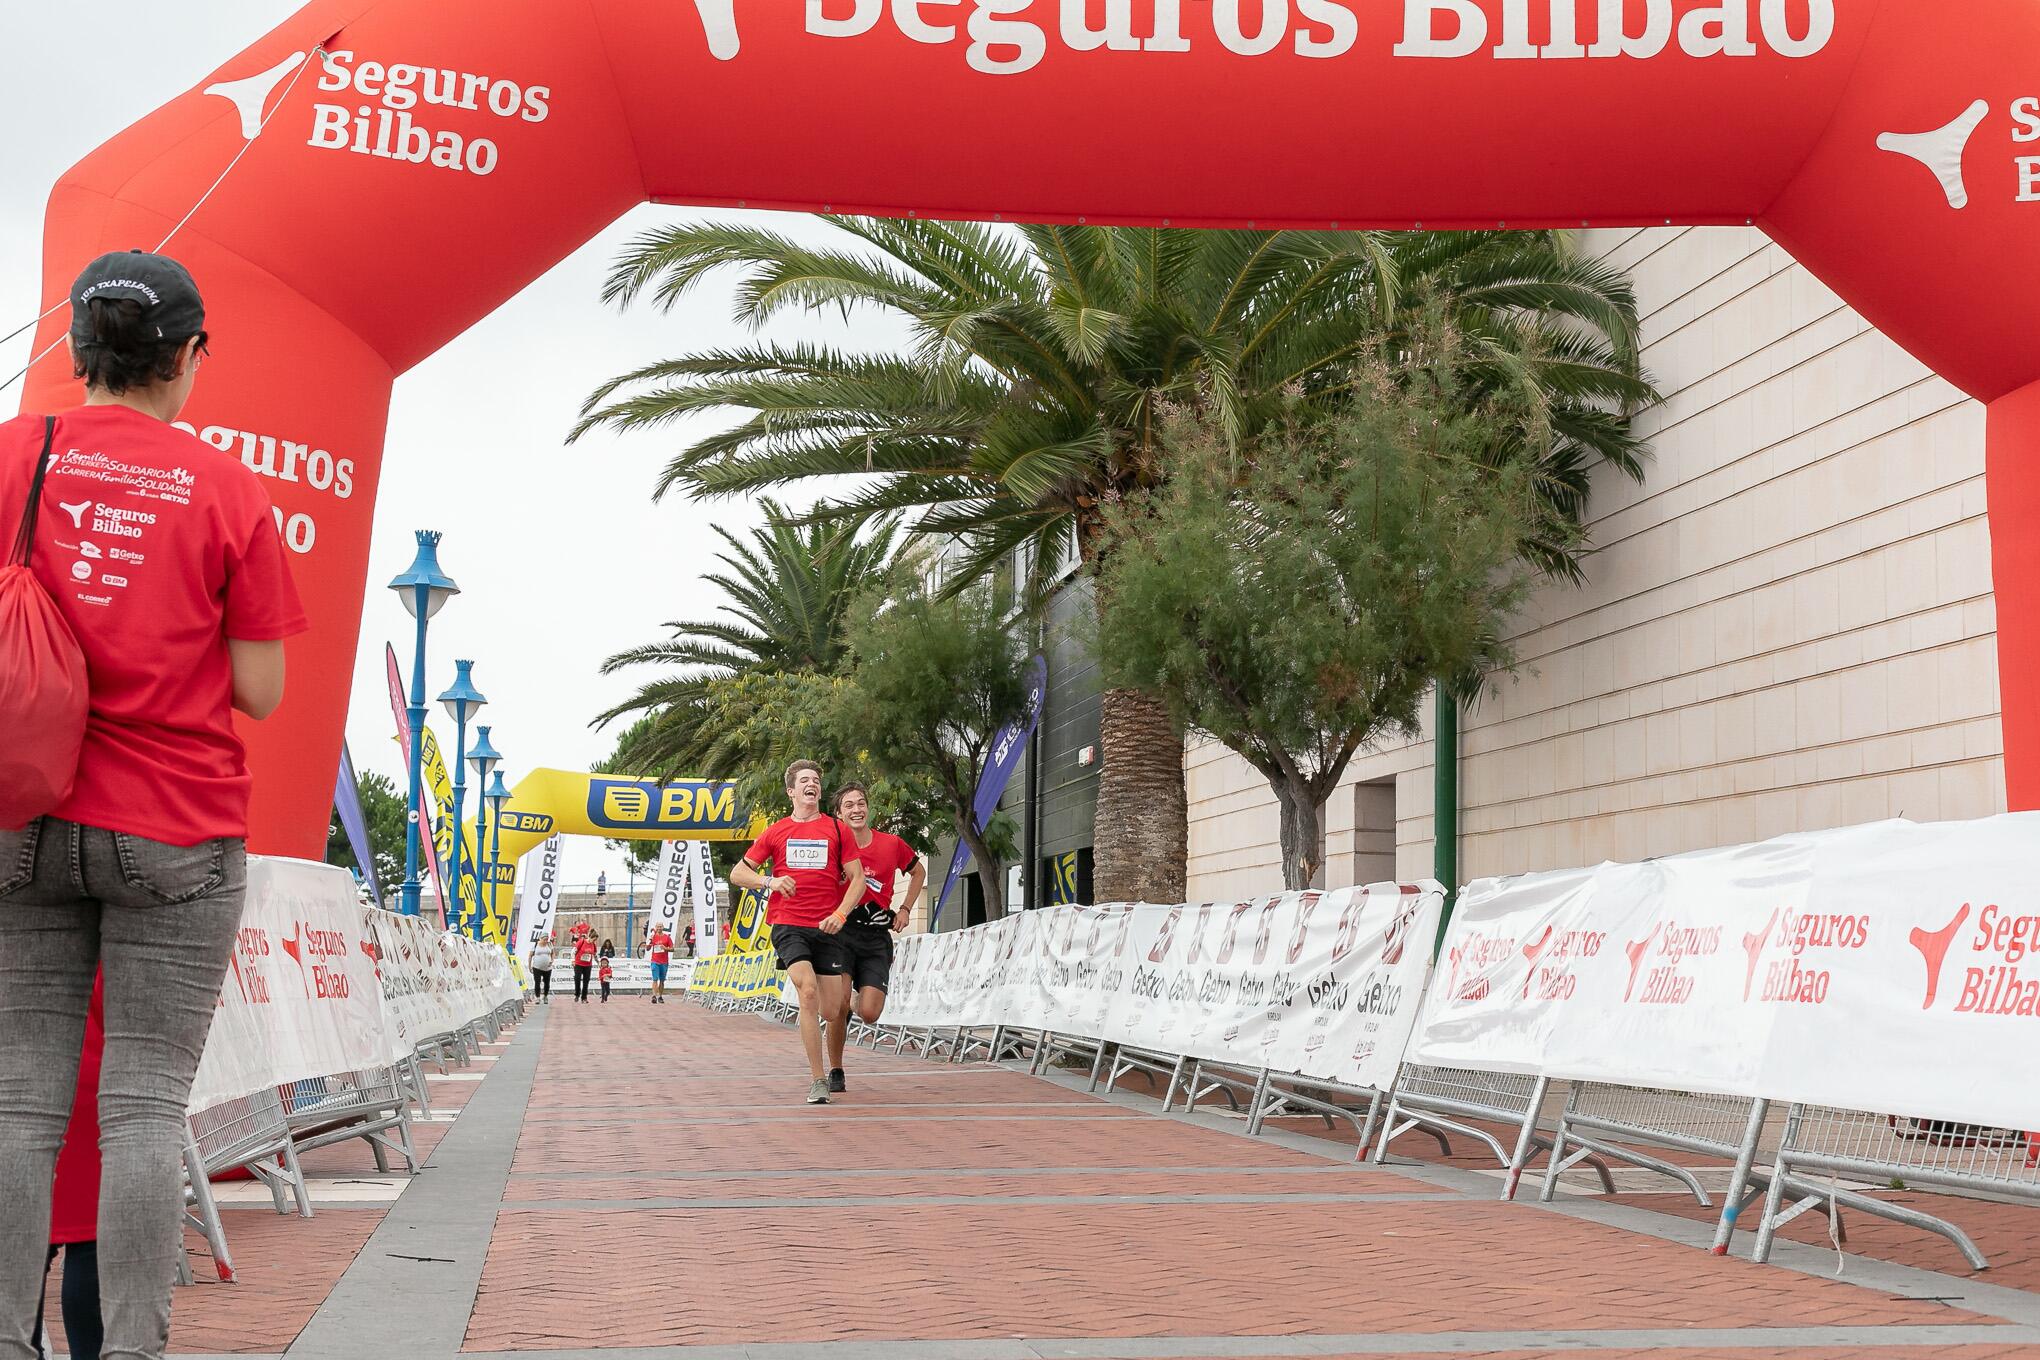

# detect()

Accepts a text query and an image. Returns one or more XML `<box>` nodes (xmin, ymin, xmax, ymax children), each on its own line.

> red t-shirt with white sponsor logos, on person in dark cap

<box><xmin>0</xmin><ymin>406</ymin><xmax>306</xmax><ymax>846</ymax></box>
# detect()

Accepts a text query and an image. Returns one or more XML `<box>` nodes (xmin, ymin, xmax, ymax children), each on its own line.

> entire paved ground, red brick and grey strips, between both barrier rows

<box><xmin>87</xmin><ymin>999</ymin><xmax>2040</xmax><ymax>1360</ymax></box>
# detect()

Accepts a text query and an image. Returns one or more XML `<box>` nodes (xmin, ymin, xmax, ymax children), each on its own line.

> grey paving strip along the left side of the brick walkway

<box><xmin>286</xmin><ymin>1007</ymin><xmax>545</xmax><ymax>1360</ymax></box>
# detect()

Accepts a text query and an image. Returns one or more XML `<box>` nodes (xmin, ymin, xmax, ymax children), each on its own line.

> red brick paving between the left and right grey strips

<box><xmin>465</xmin><ymin>1005</ymin><xmax>2040</xmax><ymax>1360</ymax></box>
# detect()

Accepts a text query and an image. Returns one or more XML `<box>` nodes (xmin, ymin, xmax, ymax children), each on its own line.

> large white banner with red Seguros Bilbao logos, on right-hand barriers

<box><xmin>1410</xmin><ymin>814</ymin><xmax>2040</xmax><ymax>1130</ymax></box>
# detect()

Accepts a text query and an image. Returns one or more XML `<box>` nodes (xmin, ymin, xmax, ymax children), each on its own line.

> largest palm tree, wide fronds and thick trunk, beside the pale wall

<box><xmin>575</xmin><ymin>216</ymin><xmax>1654</xmax><ymax>901</ymax></box>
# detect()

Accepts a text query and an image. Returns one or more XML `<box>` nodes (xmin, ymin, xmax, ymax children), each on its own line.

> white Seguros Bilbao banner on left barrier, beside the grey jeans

<box><xmin>190</xmin><ymin>856</ymin><xmax>388</xmax><ymax>1111</ymax></box>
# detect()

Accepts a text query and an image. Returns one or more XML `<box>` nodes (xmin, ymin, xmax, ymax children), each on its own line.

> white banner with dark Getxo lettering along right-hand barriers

<box><xmin>885</xmin><ymin>883</ymin><xmax>1444</xmax><ymax>1089</ymax></box>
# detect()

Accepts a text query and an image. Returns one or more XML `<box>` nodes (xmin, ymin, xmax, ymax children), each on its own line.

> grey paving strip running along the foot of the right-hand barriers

<box><xmin>1028</xmin><ymin>1073</ymin><xmax>2040</xmax><ymax>1329</ymax></box>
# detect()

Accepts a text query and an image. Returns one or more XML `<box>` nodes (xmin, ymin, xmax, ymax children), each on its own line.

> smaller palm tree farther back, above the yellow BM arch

<box><xmin>596</xmin><ymin>500</ymin><xmax>898</xmax><ymax>777</ymax></box>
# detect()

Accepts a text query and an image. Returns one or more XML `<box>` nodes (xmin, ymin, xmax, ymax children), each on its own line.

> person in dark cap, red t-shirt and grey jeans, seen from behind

<box><xmin>0</xmin><ymin>251</ymin><xmax>306</xmax><ymax>1360</ymax></box>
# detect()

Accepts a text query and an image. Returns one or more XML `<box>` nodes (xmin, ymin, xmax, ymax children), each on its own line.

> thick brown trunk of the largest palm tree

<box><xmin>1091</xmin><ymin>689</ymin><xmax>1189</xmax><ymax>903</ymax></box>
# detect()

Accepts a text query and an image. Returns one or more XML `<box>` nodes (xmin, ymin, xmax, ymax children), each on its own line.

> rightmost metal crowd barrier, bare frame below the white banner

<box><xmin>1752</xmin><ymin>1105</ymin><xmax>2040</xmax><ymax>1270</ymax></box>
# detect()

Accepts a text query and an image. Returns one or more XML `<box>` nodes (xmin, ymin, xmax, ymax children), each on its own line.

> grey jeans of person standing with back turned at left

<box><xmin>0</xmin><ymin>818</ymin><xmax>247</xmax><ymax>1360</ymax></box>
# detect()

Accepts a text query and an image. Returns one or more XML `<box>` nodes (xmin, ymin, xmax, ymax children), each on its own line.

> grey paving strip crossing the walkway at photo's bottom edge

<box><xmin>461</xmin><ymin>1325</ymin><xmax>2040</xmax><ymax>1360</ymax></box>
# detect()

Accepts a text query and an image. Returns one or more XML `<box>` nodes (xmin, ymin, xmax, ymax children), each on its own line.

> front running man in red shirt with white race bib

<box><xmin>730</xmin><ymin>761</ymin><xmax>865</xmax><ymax>1105</ymax></box>
